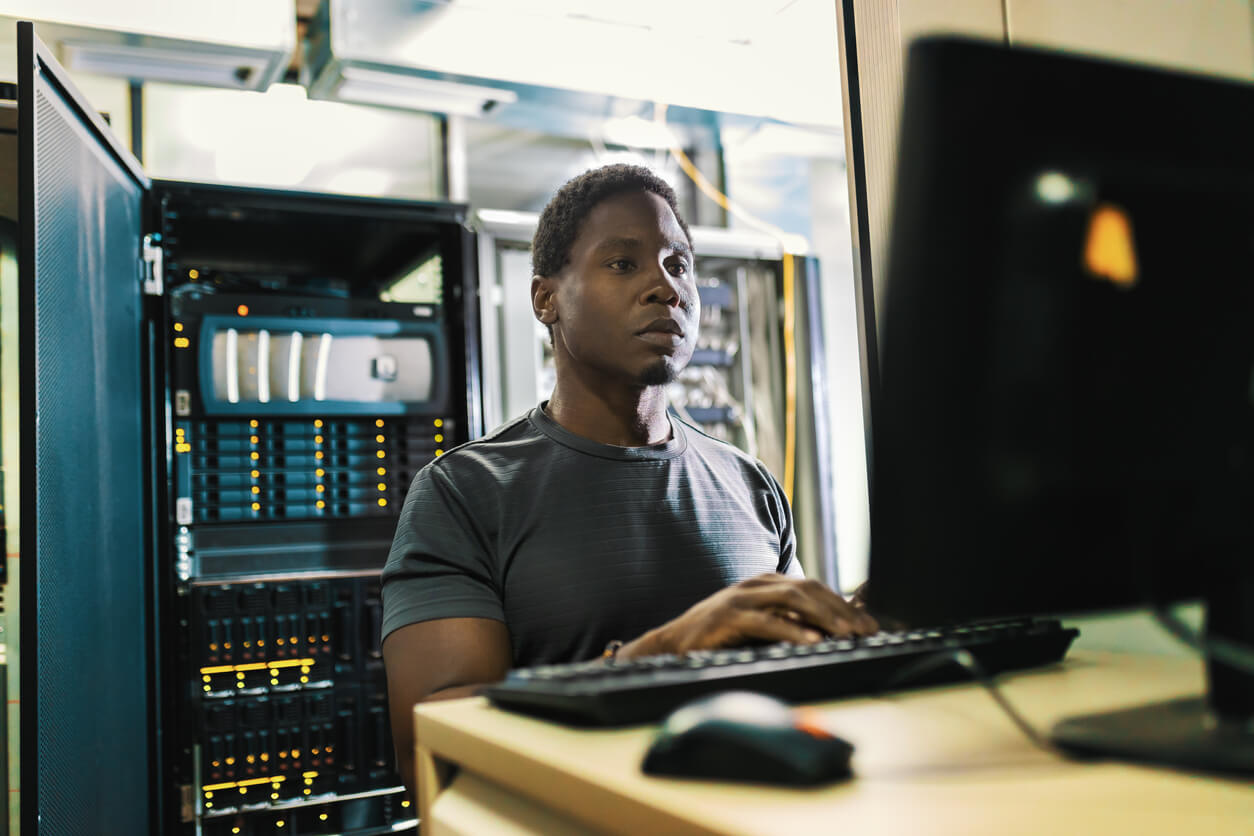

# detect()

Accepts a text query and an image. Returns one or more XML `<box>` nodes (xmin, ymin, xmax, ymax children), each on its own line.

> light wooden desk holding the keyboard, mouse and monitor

<box><xmin>415</xmin><ymin>651</ymin><xmax>1254</xmax><ymax>836</ymax></box>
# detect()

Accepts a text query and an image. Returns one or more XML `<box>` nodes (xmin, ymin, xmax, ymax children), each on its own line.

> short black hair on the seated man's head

<box><xmin>532</xmin><ymin>163</ymin><xmax>692</xmax><ymax>276</ymax></box>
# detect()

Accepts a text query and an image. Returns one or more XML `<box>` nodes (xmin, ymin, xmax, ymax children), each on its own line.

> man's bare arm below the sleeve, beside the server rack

<box><xmin>382</xmin><ymin>618</ymin><xmax>512</xmax><ymax>800</ymax></box>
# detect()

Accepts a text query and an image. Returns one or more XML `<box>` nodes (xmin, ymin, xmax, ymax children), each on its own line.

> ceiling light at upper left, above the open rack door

<box><xmin>61</xmin><ymin>41</ymin><xmax>268</xmax><ymax>89</ymax></box>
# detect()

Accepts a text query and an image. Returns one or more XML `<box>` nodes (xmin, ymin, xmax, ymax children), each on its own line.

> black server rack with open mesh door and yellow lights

<box><xmin>14</xmin><ymin>24</ymin><xmax>483</xmax><ymax>836</ymax></box>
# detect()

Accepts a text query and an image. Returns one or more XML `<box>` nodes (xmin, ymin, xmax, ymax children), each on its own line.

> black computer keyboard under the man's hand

<box><xmin>484</xmin><ymin>619</ymin><xmax>1080</xmax><ymax>726</ymax></box>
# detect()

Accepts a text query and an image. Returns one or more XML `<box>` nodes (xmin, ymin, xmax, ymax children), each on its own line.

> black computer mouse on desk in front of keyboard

<box><xmin>643</xmin><ymin>691</ymin><xmax>854</xmax><ymax>786</ymax></box>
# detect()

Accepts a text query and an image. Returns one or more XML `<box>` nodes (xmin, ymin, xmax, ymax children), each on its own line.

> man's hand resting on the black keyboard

<box><xmin>618</xmin><ymin>573</ymin><xmax>879</xmax><ymax>658</ymax></box>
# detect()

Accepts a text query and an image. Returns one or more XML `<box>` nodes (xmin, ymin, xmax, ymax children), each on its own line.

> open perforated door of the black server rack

<box><xmin>18</xmin><ymin>24</ymin><xmax>152</xmax><ymax>833</ymax></box>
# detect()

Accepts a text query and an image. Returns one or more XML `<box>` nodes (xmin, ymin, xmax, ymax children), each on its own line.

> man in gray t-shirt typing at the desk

<box><xmin>382</xmin><ymin>165</ymin><xmax>877</xmax><ymax>788</ymax></box>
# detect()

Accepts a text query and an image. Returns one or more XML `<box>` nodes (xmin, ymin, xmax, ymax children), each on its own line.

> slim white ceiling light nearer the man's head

<box><xmin>334</xmin><ymin>66</ymin><xmax>518</xmax><ymax>117</ymax></box>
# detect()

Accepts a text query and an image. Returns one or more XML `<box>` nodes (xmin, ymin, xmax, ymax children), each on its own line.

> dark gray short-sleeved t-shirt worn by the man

<box><xmin>382</xmin><ymin>405</ymin><xmax>801</xmax><ymax>666</ymax></box>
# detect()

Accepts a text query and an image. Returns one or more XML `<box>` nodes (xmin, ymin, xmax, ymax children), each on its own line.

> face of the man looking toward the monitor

<box><xmin>542</xmin><ymin>191</ymin><xmax>700</xmax><ymax>386</ymax></box>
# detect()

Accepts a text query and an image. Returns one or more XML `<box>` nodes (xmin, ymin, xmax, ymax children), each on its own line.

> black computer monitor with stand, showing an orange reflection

<box><xmin>869</xmin><ymin>39</ymin><xmax>1254</xmax><ymax>770</ymax></box>
